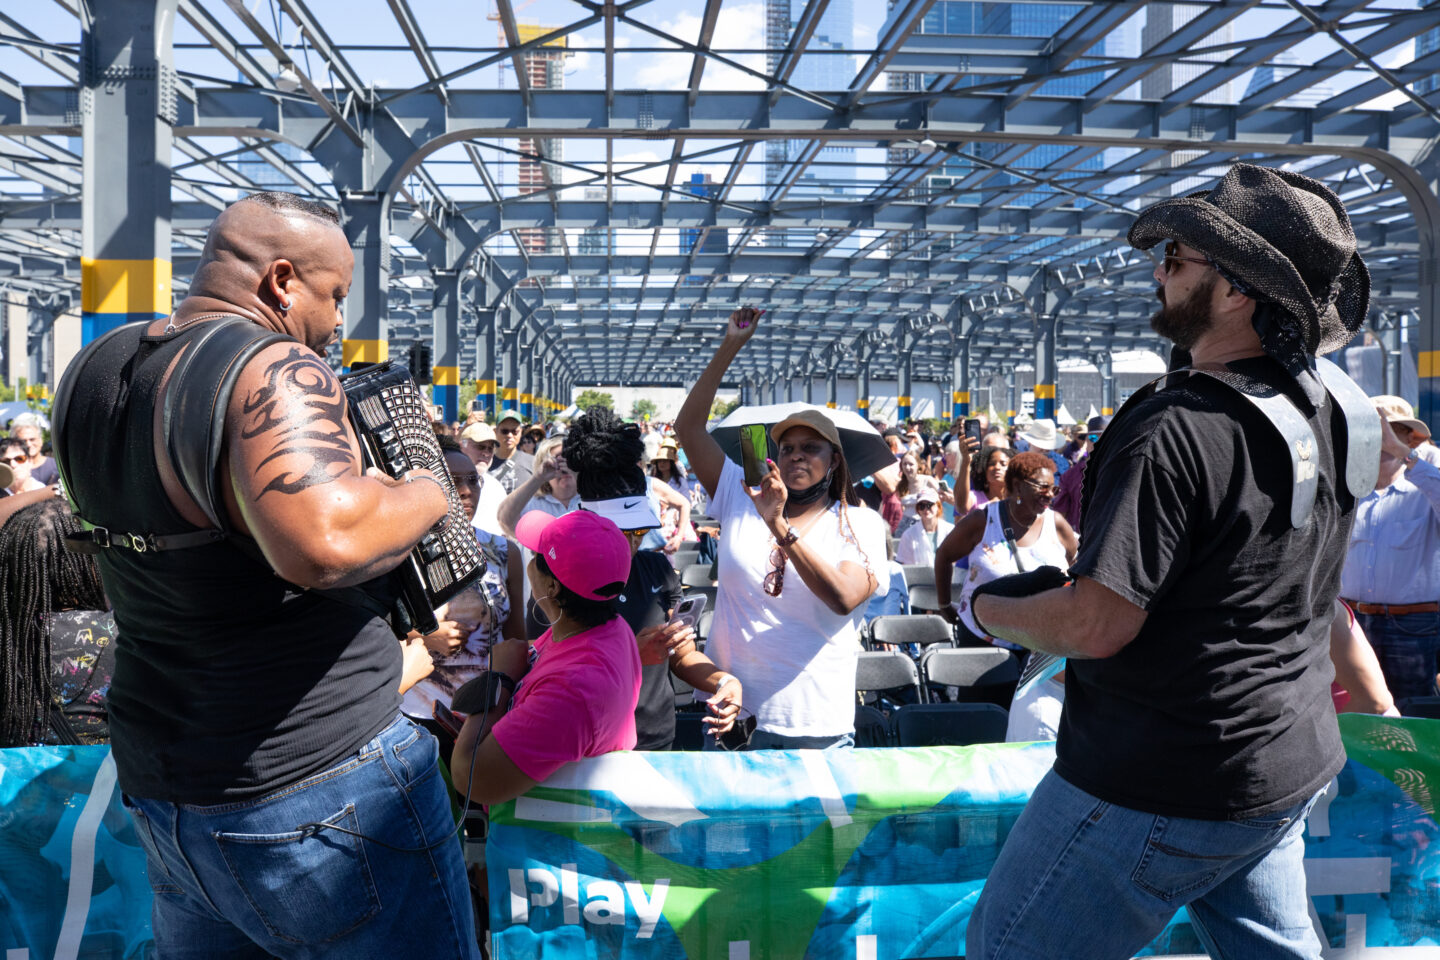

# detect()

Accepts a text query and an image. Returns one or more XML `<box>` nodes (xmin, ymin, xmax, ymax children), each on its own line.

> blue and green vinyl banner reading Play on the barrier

<box><xmin>485</xmin><ymin>714</ymin><xmax>1440</xmax><ymax>960</ymax></box>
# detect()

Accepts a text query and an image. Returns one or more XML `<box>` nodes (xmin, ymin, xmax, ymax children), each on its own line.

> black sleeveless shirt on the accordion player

<box><xmin>55</xmin><ymin>324</ymin><xmax>400</xmax><ymax>805</ymax></box>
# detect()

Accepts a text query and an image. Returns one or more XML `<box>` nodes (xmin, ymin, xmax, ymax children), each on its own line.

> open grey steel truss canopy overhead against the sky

<box><xmin>0</xmin><ymin>0</ymin><xmax>1440</xmax><ymax>408</ymax></box>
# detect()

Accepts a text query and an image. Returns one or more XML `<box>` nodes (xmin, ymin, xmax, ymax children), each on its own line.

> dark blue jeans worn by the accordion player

<box><xmin>124</xmin><ymin>717</ymin><xmax>480</xmax><ymax>960</ymax></box>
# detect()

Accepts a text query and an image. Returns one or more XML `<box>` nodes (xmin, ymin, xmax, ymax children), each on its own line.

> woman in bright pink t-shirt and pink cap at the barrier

<box><xmin>451</xmin><ymin>511</ymin><xmax>641</xmax><ymax>805</ymax></box>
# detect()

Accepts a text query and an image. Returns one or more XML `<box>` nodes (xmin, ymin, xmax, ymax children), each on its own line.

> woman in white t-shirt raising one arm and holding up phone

<box><xmin>675</xmin><ymin>307</ymin><xmax>890</xmax><ymax>750</ymax></box>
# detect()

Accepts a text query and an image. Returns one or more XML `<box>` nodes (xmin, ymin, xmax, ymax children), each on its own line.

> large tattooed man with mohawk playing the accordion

<box><xmin>55</xmin><ymin>193</ymin><xmax>477</xmax><ymax>960</ymax></box>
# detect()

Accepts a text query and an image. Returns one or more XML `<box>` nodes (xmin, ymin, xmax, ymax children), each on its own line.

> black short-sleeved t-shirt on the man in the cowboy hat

<box><xmin>1056</xmin><ymin>358</ymin><xmax>1355</xmax><ymax>819</ymax></box>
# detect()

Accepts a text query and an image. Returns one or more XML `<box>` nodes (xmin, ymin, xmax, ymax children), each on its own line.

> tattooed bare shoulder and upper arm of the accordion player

<box><xmin>228</xmin><ymin>343</ymin><xmax>360</xmax><ymax>501</ymax></box>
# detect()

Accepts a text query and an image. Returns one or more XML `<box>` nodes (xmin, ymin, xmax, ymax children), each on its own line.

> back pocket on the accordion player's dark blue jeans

<box><xmin>215</xmin><ymin>805</ymin><xmax>380</xmax><ymax>943</ymax></box>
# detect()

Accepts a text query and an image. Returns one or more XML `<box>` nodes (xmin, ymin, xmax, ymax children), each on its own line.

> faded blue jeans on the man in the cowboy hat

<box><xmin>965</xmin><ymin>770</ymin><xmax>1320</xmax><ymax>960</ymax></box>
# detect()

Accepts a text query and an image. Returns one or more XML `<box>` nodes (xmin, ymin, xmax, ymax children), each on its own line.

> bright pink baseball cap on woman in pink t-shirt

<box><xmin>516</xmin><ymin>510</ymin><xmax>631</xmax><ymax>600</ymax></box>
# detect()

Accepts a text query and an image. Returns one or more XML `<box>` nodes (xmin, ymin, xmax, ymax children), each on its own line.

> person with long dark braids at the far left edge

<box><xmin>0</xmin><ymin>499</ymin><xmax>115</xmax><ymax>747</ymax></box>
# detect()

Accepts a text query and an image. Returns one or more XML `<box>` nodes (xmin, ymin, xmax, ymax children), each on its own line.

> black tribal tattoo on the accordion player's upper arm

<box><xmin>240</xmin><ymin>347</ymin><xmax>356</xmax><ymax>502</ymax></box>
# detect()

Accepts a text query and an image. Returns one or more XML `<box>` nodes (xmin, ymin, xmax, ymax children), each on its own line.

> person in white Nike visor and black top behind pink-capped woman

<box><xmin>564</xmin><ymin>407</ymin><xmax>742</xmax><ymax>750</ymax></box>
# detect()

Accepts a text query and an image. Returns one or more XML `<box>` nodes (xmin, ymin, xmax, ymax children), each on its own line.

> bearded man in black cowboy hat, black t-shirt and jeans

<box><xmin>966</xmin><ymin>164</ymin><xmax>1380</xmax><ymax>960</ymax></box>
